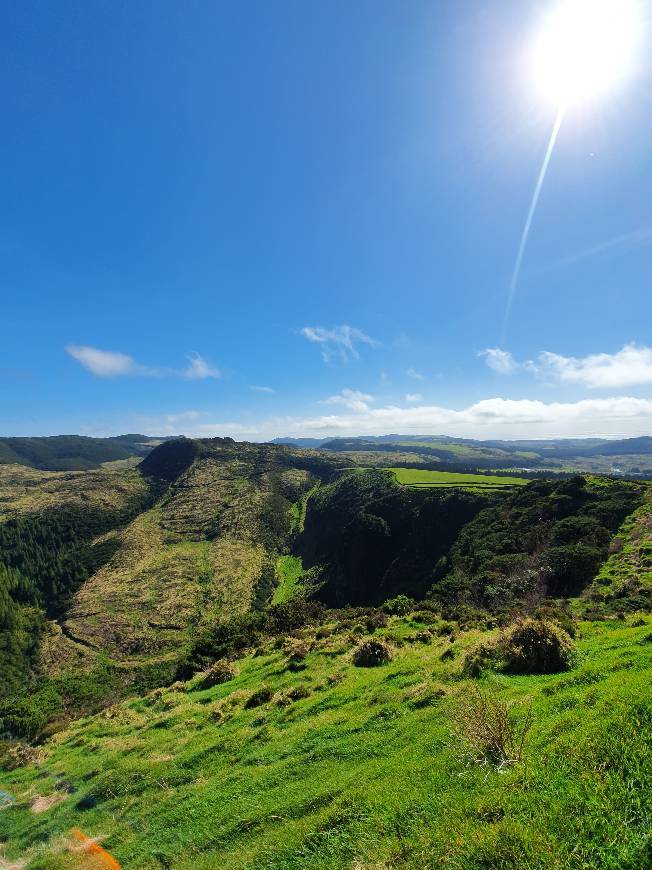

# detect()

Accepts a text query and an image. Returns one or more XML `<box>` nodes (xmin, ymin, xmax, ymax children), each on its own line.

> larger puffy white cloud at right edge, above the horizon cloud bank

<box><xmin>531</xmin><ymin>344</ymin><xmax>652</xmax><ymax>389</ymax></box>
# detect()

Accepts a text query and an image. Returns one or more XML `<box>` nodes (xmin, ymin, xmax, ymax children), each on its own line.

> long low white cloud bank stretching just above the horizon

<box><xmin>136</xmin><ymin>398</ymin><xmax>652</xmax><ymax>441</ymax></box>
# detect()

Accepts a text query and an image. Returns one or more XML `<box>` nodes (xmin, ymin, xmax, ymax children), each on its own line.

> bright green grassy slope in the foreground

<box><xmin>0</xmin><ymin>619</ymin><xmax>652</xmax><ymax>870</ymax></box>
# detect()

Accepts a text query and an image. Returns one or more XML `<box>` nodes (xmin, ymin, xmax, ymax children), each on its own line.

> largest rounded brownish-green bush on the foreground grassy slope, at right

<box><xmin>500</xmin><ymin>619</ymin><xmax>577</xmax><ymax>674</ymax></box>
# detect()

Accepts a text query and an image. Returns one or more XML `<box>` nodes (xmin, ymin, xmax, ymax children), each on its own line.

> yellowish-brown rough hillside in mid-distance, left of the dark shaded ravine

<box><xmin>45</xmin><ymin>442</ymin><xmax>326</xmax><ymax>670</ymax></box>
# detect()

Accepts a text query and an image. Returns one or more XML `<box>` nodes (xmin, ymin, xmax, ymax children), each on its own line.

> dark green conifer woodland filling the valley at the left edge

<box><xmin>0</xmin><ymin>481</ymin><xmax>157</xmax><ymax>736</ymax></box>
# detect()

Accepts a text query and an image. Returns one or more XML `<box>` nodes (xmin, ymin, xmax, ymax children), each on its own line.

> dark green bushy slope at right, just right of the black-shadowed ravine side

<box><xmin>432</xmin><ymin>477</ymin><xmax>646</xmax><ymax>612</ymax></box>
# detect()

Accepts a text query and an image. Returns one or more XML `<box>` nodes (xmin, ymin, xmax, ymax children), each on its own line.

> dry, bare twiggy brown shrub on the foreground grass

<box><xmin>455</xmin><ymin>686</ymin><xmax>532</xmax><ymax>767</ymax></box>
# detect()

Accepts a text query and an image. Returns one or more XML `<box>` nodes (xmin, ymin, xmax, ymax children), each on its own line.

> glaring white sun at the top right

<box><xmin>531</xmin><ymin>0</ymin><xmax>643</xmax><ymax>107</ymax></box>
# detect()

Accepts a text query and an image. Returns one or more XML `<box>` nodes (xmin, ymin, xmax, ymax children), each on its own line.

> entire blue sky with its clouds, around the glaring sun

<box><xmin>0</xmin><ymin>0</ymin><xmax>652</xmax><ymax>439</ymax></box>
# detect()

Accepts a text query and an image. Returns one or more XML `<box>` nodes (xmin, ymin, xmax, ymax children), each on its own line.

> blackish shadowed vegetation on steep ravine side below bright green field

<box><xmin>295</xmin><ymin>469</ymin><xmax>495</xmax><ymax>606</ymax></box>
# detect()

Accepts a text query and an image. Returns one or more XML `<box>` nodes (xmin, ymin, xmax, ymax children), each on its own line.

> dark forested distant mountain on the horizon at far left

<box><xmin>0</xmin><ymin>434</ymin><xmax>171</xmax><ymax>471</ymax></box>
